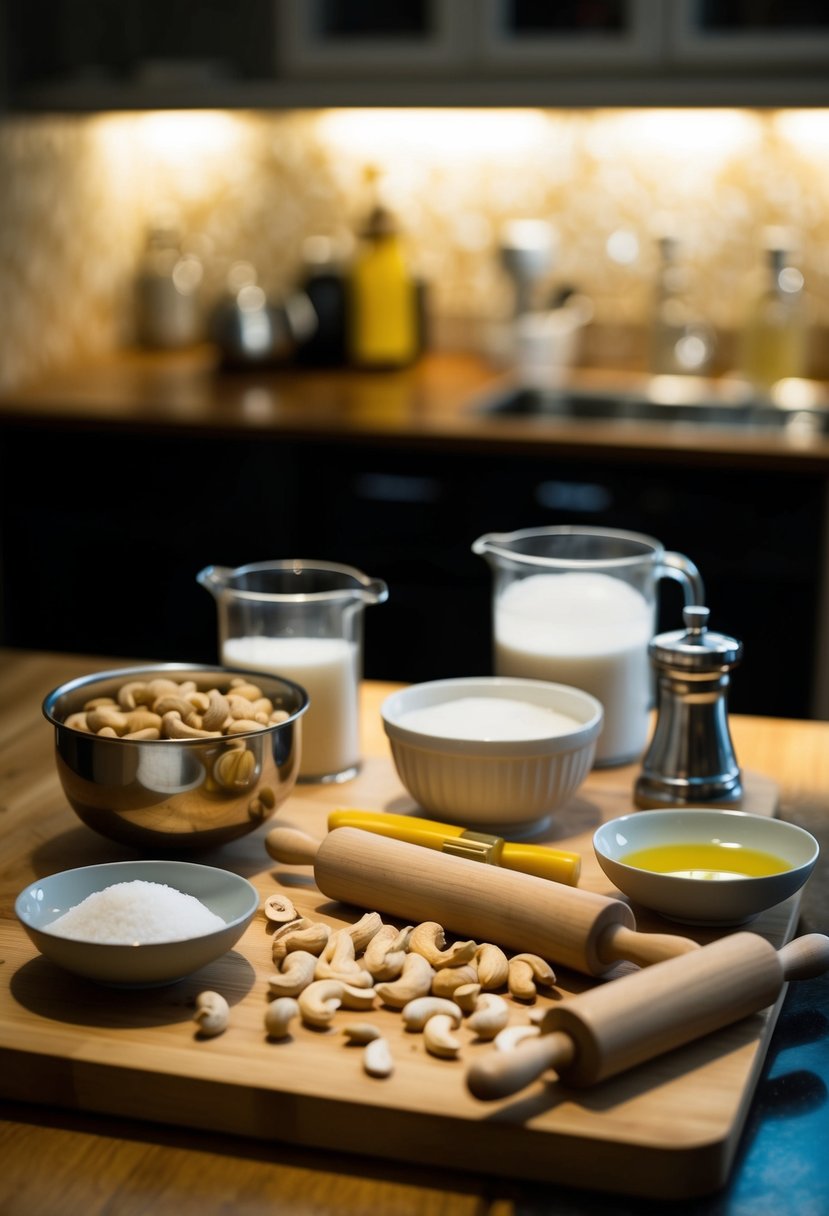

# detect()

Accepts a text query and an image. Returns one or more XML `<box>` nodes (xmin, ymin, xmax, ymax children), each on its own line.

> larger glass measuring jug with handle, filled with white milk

<box><xmin>472</xmin><ymin>525</ymin><xmax>705</xmax><ymax>766</ymax></box>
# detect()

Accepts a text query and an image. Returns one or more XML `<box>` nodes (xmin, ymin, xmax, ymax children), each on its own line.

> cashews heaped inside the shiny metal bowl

<box><xmin>64</xmin><ymin>676</ymin><xmax>291</xmax><ymax>739</ymax></box>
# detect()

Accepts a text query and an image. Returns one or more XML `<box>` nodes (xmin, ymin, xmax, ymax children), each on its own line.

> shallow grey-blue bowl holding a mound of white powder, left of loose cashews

<box><xmin>15</xmin><ymin>861</ymin><xmax>259</xmax><ymax>987</ymax></box>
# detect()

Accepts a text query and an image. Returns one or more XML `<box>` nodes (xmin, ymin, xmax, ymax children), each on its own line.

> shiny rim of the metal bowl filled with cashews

<box><xmin>40</xmin><ymin>662</ymin><xmax>311</xmax><ymax>748</ymax></box>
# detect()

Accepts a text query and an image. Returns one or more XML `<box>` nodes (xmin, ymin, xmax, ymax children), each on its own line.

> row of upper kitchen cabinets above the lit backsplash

<box><xmin>0</xmin><ymin>0</ymin><xmax>829</xmax><ymax>111</ymax></box>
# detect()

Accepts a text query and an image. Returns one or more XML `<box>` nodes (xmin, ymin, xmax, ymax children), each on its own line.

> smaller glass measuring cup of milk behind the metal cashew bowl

<box><xmin>196</xmin><ymin>559</ymin><xmax>389</xmax><ymax>782</ymax></box>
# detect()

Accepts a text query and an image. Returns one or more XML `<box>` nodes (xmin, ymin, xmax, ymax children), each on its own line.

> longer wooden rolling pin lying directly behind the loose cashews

<box><xmin>265</xmin><ymin>827</ymin><xmax>699</xmax><ymax>975</ymax></box>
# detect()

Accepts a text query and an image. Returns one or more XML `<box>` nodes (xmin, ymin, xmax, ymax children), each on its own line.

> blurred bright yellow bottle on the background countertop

<box><xmin>348</xmin><ymin>207</ymin><xmax>418</xmax><ymax>368</ymax></box>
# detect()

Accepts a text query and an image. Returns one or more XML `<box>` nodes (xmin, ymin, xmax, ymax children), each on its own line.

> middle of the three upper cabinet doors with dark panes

<box><xmin>476</xmin><ymin>0</ymin><xmax>664</xmax><ymax>71</ymax></box>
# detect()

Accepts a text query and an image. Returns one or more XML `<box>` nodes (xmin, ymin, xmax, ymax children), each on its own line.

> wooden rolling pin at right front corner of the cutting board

<box><xmin>467</xmin><ymin>933</ymin><xmax>829</xmax><ymax>1099</ymax></box>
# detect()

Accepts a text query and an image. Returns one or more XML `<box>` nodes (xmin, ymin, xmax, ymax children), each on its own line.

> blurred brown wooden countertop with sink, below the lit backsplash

<box><xmin>0</xmin><ymin>347</ymin><xmax>829</xmax><ymax>472</ymax></box>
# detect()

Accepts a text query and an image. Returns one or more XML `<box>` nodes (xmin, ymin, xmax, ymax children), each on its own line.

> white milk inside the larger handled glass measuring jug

<box><xmin>495</xmin><ymin>573</ymin><xmax>654</xmax><ymax>764</ymax></box>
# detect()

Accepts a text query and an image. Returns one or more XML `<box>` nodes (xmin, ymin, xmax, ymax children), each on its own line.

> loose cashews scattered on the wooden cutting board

<box><xmin>196</xmin><ymin>894</ymin><xmax>556</xmax><ymax>1077</ymax></box>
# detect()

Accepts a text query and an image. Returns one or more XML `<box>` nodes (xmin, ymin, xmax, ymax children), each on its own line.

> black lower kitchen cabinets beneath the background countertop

<box><xmin>0</xmin><ymin>422</ymin><xmax>827</xmax><ymax>717</ymax></box>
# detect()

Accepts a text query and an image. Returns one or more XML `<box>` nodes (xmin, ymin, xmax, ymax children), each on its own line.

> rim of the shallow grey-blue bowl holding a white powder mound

<box><xmin>15</xmin><ymin>858</ymin><xmax>259</xmax><ymax>955</ymax></box>
